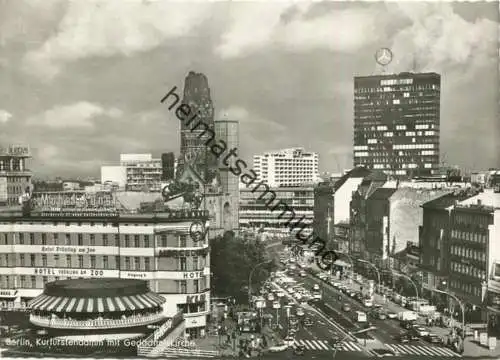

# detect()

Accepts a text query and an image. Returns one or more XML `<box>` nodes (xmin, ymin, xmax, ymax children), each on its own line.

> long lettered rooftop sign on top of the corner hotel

<box><xmin>31</xmin><ymin>191</ymin><xmax>116</xmax><ymax>213</ymax></box>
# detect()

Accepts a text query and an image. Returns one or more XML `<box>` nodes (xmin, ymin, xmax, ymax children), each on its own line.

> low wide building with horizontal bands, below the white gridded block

<box><xmin>239</xmin><ymin>186</ymin><xmax>314</xmax><ymax>235</ymax></box>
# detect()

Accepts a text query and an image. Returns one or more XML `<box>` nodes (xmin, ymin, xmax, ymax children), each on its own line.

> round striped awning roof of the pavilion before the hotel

<box><xmin>29</xmin><ymin>292</ymin><xmax>165</xmax><ymax>313</ymax></box>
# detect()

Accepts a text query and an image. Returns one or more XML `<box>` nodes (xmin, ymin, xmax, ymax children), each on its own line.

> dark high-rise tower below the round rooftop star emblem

<box><xmin>354</xmin><ymin>73</ymin><xmax>441</xmax><ymax>177</ymax></box>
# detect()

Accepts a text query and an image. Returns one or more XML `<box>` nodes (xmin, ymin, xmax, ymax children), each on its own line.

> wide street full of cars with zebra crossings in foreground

<box><xmin>261</xmin><ymin>255</ymin><xmax>461</xmax><ymax>359</ymax></box>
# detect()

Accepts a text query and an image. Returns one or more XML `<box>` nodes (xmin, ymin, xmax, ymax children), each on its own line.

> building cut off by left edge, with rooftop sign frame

<box><xmin>0</xmin><ymin>145</ymin><xmax>32</xmax><ymax>206</ymax></box>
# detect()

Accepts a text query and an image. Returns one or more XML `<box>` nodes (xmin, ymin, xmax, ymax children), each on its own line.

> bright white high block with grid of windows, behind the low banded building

<box><xmin>253</xmin><ymin>148</ymin><xmax>319</xmax><ymax>187</ymax></box>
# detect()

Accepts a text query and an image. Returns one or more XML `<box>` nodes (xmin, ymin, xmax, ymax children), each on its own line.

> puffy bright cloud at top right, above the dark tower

<box><xmin>382</xmin><ymin>2</ymin><xmax>498</xmax><ymax>78</ymax></box>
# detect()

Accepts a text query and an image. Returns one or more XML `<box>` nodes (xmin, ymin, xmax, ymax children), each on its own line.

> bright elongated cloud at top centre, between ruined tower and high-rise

<box><xmin>215</xmin><ymin>2</ymin><xmax>379</xmax><ymax>58</ymax></box>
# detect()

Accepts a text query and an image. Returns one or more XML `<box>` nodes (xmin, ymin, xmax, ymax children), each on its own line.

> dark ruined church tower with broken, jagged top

<box><xmin>179</xmin><ymin>71</ymin><xmax>217</xmax><ymax>182</ymax></box>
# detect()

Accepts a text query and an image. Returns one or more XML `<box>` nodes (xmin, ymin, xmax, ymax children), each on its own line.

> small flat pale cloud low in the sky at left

<box><xmin>27</xmin><ymin>101</ymin><xmax>122</xmax><ymax>128</ymax></box>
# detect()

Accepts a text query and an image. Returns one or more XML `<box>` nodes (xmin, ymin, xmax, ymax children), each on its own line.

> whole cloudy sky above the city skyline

<box><xmin>0</xmin><ymin>0</ymin><xmax>500</xmax><ymax>177</ymax></box>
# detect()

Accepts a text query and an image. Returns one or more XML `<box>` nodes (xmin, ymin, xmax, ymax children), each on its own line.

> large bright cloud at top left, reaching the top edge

<box><xmin>24</xmin><ymin>0</ymin><xmax>210</xmax><ymax>79</ymax></box>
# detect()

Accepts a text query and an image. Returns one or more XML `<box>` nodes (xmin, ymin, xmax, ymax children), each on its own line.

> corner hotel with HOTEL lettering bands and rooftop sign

<box><xmin>0</xmin><ymin>192</ymin><xmax>210</xmax><ymax>337</ymax></box>
